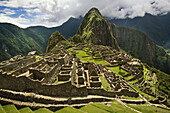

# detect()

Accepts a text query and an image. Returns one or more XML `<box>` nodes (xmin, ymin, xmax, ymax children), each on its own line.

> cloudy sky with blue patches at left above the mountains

<box><xmin>0</xmin><ymin>0</ymin><xmax>170</xmax><ymax>28</ymax></box>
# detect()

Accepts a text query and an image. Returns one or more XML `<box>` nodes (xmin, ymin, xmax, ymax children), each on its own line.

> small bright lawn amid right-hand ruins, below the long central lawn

<box><xmin>107</xmin><ymin>66</ymin><xmax>127</xmax><ymax>78</ymax></box>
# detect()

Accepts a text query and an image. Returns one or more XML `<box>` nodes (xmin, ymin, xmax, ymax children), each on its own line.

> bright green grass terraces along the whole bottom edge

<box><xmin>0</xmin><ymin>98</ymin><xmax>169</xmax><ymax>113</ymax></box>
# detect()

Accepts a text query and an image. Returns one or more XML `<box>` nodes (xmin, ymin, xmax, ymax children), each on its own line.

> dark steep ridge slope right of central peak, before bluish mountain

<box><xmin>112</xmin><ymin>24</ymin><xmax>170</xmax><ymax>73</ymax></box>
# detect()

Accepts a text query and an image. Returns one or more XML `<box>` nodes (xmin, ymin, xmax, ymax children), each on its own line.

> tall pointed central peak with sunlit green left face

<box><xmin>77</xmin><ymin>8</ymin><xmax>119</xmax><ymax>50</ymax></box>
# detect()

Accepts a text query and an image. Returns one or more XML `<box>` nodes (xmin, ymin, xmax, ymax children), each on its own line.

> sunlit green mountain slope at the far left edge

<box><xmin>0</xmin><ymin>24</ymin><xmax>48</xmax><ymax>60</ymax></box>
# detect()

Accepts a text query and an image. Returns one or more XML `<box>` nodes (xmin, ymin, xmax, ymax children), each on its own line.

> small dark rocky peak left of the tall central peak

<box><xmin>46</xmin><ymin>31</ymin><xmax>66</xmax><ymax>53</ymax></box>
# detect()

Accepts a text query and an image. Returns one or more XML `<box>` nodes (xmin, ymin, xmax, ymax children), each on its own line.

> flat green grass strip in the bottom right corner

<box><xmin>128</xmin><ymin>105</ymin><xmax>170</xmax><ymax>113</ymax></box>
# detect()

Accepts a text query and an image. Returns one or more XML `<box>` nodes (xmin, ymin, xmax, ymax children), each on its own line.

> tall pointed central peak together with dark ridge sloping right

<box><xmin>73</xmin><ymin>8</ymin><xmax>170</xmax><ymax>73</ymax></box>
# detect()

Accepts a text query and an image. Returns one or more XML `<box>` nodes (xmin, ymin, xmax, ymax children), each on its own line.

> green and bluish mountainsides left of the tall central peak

<box><xmin>0</xmin><ymin>18</ymin><xmax>82</xmax><ymax>61</ymax></box>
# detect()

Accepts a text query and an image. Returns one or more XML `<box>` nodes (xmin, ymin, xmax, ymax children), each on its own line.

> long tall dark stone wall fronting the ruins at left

<box><xmin>0</xmin><ymin>75</ymin><xmax>88</xmax><ymax>97</ymax></box>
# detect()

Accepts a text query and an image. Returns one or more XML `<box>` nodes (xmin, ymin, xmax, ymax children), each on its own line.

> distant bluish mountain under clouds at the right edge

<box><xmin>108</xmin><ymin>13</ymin><xmax>170</xmax><ymax>50</ymax></box>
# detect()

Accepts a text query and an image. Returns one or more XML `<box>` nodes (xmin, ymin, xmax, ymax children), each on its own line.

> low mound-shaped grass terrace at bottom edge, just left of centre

<box><xmin>55</xmin><ymin>106</ymin><xmax>85</xmax><ymax>113</ymax></box>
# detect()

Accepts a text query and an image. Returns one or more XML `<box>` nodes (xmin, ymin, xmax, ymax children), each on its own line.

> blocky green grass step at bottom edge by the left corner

<box><xmin>3</xmin><ymin>105</ymin><xmax>19</xmax><ymax>113</ymax></box>
